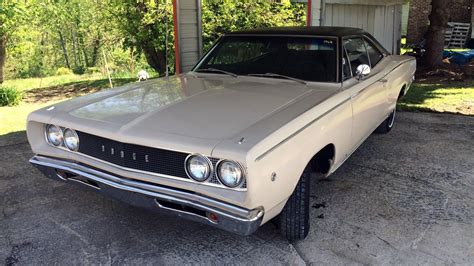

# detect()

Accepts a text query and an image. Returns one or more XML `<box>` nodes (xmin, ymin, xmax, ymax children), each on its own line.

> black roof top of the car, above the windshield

<box><xmin>226</xmin><ymin>26</ymin><xmax>367</xmax><ymax>37</ymax></box>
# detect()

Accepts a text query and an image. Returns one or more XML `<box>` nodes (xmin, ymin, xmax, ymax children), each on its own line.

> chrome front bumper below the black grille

<box><xmin>30</xmin><ymin>155</ymin><xmax>264</xmax><ymax>235</ymax></box>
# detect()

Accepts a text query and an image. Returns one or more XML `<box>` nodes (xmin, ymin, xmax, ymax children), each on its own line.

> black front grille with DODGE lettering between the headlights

<box><xmin>77</xmin><ymin>131</ymin><xmax>246</xmax><ymax>188</ymax></box>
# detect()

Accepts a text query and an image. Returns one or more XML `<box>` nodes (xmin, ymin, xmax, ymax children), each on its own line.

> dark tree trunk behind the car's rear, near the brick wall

<box><xmin>423</xmin><ymin>0</ymin><xmax>453</xmax><ymax>68</ymax></box>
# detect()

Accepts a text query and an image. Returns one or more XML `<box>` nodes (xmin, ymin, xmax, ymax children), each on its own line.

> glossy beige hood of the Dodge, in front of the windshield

<box><xmin>66</xmin><ymin>74</ymin><xmax>311</xmax><ymax>140</ymax></box>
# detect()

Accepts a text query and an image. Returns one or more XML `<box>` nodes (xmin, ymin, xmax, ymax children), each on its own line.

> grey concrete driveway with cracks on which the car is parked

<box><xmin>0</xmin><ymin>113</ymin><xmax>474</xmax><ymax>265</ymax></box>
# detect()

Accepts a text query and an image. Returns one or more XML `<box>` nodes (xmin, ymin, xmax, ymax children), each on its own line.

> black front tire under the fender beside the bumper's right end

<box><xmin>278</xmin><ymin>167</ymin><xmax>311</xmax><ymax>242</ymax></box>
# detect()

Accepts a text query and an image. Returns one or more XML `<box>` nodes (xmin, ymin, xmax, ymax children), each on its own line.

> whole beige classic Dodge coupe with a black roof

<box><xmin>28</xmin><ymin>27</ymin><xmax>416</xmax><ymax>241</ymax></box>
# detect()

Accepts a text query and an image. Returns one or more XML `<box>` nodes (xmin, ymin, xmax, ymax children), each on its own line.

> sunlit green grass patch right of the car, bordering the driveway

<box><xmin>398</xmin><ymin>81</ymin><xmax>474</xmax><ymax>115</ymax></box>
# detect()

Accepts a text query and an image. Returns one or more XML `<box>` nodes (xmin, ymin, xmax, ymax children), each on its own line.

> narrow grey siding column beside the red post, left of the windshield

<box><xmin>177</xmin><ymin>0</ymin><xmax>201</xmax><ymax>72</ymax></box>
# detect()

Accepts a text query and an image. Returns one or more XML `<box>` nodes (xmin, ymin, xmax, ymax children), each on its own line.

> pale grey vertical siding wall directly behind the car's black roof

<box><xmin>311</xmin><ymin>1</ymin><xmax>401</xmax><ymax>54</ymax></box>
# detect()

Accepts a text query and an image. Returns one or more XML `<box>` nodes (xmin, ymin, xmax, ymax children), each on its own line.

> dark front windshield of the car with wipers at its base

<box><xmin>194</xmin><ymin>36</ymin><xmax>337</xmax><ymax>82</ymax></box>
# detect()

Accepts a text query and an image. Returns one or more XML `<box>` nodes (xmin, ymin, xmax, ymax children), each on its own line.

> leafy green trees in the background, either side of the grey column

<box><xmin>0</xmin><ymin>0</ymin><xmax>306</xmax><ymax>79</ymax></box>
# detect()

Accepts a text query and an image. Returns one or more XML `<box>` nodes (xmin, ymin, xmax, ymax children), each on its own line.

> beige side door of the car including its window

<box><xmin>343</xmin><ymin>37</ymin><xmax>387</xmax><ymax>148</ymax></box>
